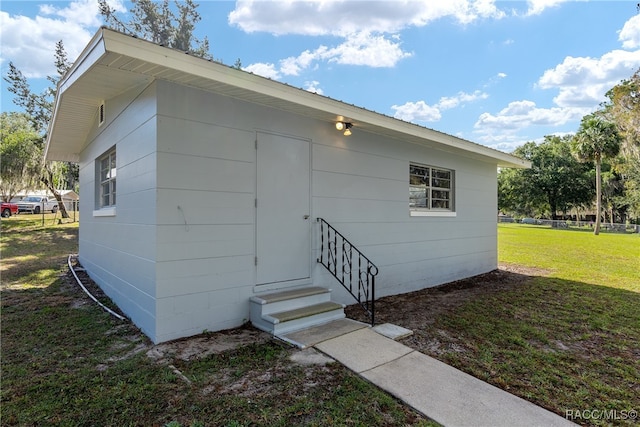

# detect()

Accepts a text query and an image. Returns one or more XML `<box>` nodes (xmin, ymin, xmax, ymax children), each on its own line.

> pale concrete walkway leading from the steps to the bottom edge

<box><xmin>283</xmin><ymin>319</ymin><xmax>575</xmax><ymax>427</ymax></box>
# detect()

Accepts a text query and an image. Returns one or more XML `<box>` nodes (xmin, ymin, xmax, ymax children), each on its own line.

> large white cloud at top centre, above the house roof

<box><xmin>234</xmin><ymin>0</ymin><xmax>505</xmax><ymax>84</ymax></box>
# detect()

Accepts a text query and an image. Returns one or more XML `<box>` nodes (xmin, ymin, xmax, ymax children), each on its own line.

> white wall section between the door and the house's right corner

<box><xmin>312</xmin><ymin>129</ymin><xmax>497</xmax><ymax>304</ymax></box>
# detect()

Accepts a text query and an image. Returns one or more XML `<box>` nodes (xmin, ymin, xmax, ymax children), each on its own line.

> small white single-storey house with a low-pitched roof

<box><xmin>45</xmin><ymin>28</ymin><xmax>529</xmax><ymax>343</ymax></box>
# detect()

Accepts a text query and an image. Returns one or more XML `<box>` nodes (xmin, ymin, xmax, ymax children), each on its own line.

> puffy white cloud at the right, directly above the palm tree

<box><xmin>538</xmin><ymin>50</ymin><xmax>640</xmax><ymax>107</ymax></box>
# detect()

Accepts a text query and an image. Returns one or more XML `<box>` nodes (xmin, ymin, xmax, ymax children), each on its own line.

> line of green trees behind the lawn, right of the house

<box><xmin>498</xmin><ymin>69</ymin><xmax>640</xmax><ymax>234</ymax></box>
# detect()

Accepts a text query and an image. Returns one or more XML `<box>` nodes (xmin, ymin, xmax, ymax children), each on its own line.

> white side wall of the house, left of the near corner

<box><xmin>79</xmin><ymin>84</ymin><xmax>157</xmax><ymax>337</ymax></box>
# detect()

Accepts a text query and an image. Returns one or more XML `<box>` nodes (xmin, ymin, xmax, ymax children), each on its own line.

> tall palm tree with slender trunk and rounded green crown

<box><xmin>571</xmin><ymin>112</ymin><xmax>622</xmax><ymax>235</ymax></box>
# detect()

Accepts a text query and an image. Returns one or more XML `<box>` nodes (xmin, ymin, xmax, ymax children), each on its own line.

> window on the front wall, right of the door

<box><xmin>409</xmin><ymin>163</ymin><xmax>454</xmax><ymax>212</ymax></box>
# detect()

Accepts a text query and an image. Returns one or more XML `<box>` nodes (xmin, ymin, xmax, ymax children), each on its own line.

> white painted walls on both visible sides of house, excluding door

<box><xmin>80</xmin><ymin>81</ymin><xmax>497</xmax><ymax>343</ymax></box>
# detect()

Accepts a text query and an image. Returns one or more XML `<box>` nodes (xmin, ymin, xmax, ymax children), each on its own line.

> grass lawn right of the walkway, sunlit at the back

<box><xmin>424</xmin><ymin>224</ymin><xmax>640</xmax><ymax>425</ymax></box>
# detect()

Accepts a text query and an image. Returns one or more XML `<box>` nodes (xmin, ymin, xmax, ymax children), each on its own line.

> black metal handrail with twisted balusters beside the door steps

<box><xmin>316</xmin><ymin>218</ymin><xmax>378</xmax><ymax>326</ymax></box>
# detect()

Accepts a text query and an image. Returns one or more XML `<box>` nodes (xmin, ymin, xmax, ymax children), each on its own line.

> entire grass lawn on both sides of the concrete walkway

<box><xmin>0</xmin><ymin>215</ymin><xmax>640</xmax><ymax>427</ymax></box>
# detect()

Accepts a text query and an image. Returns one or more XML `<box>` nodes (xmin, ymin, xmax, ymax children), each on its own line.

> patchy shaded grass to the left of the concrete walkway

<box><xmin>0</xmin><ymin>215</ymin><xmax>434</xmax><ymax>427</ymax></box>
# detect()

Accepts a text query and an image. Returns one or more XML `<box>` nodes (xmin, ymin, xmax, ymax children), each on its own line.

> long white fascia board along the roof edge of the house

<box><xmin>50</xmin><ymin>28</ymin><xmax>530</xmax><ymax>168</ymax></box>
